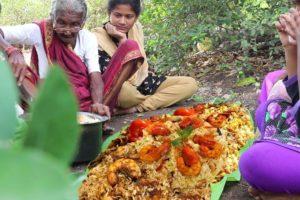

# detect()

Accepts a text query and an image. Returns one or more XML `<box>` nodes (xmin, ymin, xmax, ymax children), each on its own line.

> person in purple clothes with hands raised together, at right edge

<box><xmin>240</xmin><ymin>1</ymin><xmax>300</xmax><ymax>200</ymax></box>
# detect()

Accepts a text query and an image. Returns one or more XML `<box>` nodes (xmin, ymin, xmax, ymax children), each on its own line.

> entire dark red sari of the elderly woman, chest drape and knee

<box><xmin>31</xmin><ymin>20</ymin><xmax>143</xmax><ymax>111</ymax></box>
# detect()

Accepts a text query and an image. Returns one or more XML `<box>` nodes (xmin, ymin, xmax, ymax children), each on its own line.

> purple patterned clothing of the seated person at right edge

<box><xmin>239</xmin><ymin>70</ymin><xmax>300</xmax><ymax>194</ymax></box>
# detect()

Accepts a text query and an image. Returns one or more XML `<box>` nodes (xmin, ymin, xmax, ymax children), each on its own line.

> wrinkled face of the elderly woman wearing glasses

<box><xmin>53</xmin><ymin>11</ymin><xmax>83</xmax><ymax>46</ymax></box>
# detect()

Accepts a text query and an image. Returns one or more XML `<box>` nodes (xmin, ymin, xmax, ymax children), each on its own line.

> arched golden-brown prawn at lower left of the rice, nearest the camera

<box><xmin>107</xmin><ymin>158</ymin><xmax>142</xmax><ymax>186</ymax></box>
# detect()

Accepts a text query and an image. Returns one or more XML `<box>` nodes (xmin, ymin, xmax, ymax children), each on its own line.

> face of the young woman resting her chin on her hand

<box><xmin>109</xmin><ymin>4</ymin><xmax>137</xmax><ymax>33</ymax></box>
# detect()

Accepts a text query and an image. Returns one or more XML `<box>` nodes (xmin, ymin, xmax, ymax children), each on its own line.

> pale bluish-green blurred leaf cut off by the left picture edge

<box><xmin>0</xmin><ymin>61</ymin><xmax>17</xmax><ymax>144</ymax></box>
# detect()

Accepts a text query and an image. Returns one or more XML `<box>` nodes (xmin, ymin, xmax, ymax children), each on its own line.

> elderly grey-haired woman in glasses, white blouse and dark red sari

<box><xmin>0</xmin><ymin>0</ymin><xmax>143</xmax><ymax>116</ymax></box>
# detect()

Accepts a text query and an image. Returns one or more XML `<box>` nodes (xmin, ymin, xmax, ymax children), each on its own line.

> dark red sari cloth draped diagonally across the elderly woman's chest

<box><xmin>32</xmin><ymin>20</ymin><xmax>92</xmax><ymax>111</ymax></box>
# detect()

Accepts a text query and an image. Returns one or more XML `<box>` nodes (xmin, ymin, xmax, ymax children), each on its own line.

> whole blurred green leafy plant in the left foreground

<box><xmin>0</xmin><ymin>61</ymin><xmax>79</xmax><ymax>200</ymax></box>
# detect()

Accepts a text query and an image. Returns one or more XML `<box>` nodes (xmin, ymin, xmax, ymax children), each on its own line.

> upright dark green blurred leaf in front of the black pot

<box><xmin>24</xmin><ymin>67</ymin><xmax>79</xmax><ymax>164</ymax></box>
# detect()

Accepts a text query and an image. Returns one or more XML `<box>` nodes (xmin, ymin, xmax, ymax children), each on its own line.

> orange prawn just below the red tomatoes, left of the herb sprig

<box><xmin>138</xmin><ymin>141</ymin><xmax>171</xmax><ymax>162</ymax></box>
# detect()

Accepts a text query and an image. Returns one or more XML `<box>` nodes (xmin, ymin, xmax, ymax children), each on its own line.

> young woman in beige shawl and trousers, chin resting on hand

<box><xmin>94</xmin><ymin>0</ymin><xmax>197</xmax><ymax>114</ymax></box>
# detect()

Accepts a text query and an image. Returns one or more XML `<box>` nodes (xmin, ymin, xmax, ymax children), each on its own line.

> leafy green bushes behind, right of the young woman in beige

<box><xmin>141</xmin><ymin>0</ymin><xmax>291</xmax><ymax>76</ymax></box>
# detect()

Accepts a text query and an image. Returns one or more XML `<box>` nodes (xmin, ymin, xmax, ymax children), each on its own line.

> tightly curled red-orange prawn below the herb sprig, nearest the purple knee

<box><xmin>176</xmin><ymin>146</ymin><xmax>201</xmax><ymax>176</ymax></box>
